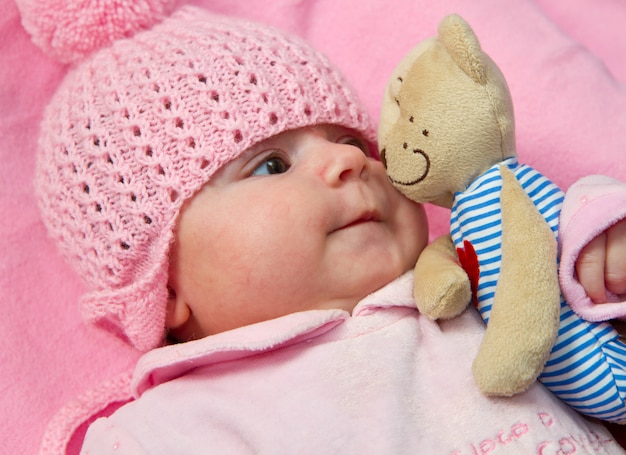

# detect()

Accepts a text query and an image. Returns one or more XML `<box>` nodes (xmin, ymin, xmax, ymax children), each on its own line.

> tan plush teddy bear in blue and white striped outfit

<box><xmin>378</xmin><ymin>14</ymin><xmax>626</xmax><ymax>420</ymax></box>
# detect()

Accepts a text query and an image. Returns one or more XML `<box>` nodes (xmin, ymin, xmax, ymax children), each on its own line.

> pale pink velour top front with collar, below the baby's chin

<box><xmin>82</xmin><ymin>273</ymin><xmax>624</xmax><ymax>455</ymax></box>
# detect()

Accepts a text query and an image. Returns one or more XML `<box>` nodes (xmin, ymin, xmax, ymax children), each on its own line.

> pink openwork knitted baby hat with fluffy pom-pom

<box><xmin>22</xmin><ymin>0</ymin><xmax>374</xmax><ymax>350</ymax></box>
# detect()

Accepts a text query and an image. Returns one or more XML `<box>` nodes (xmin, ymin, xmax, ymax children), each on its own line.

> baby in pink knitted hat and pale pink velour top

<box><xmin>28</xmin><ymin>1</ymin><xmax>623</xmax><ymax>454</ymax></box>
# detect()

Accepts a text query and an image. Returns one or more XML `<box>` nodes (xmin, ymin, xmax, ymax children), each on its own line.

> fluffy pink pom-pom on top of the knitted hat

<box><xmin>16</xmin><ymin>0</ymin><xmax>176</xmax><ymax>63</ymax></box>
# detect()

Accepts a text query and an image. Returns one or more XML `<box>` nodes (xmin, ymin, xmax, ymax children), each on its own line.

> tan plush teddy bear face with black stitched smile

<box><xmin>379</xmin><ymin>20</ymin><xmax>512</xmax><ymax>207</ymax></box>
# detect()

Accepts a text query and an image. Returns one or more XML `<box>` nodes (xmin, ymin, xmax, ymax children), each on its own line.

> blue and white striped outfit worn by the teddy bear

<box><xmin>450</xmin><ymin>158</ymin><xmax>626</xmax><ymax>422</ymax></box>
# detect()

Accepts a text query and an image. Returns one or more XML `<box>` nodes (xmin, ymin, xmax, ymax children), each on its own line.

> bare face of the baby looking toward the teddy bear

<box><xmin>168</xmin><ymin>126</ymin><xmax>428</xmax><ymax>339</ymax></box>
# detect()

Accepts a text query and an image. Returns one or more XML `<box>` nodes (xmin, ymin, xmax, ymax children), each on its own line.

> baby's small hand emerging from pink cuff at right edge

<box><xmin>576</xmin><ymin>219</ymin><xmax>626</xmax><ymax>303</ymax></box>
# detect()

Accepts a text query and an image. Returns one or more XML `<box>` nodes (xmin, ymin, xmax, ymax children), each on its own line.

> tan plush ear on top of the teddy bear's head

<box><xmin>439</xmin><ymin>14</ymin><xmax>487</xmax><ymax>85</ymax></box>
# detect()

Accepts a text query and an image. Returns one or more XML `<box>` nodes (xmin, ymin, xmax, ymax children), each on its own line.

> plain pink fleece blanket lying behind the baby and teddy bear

<box><xmin>0</xmin><ymin>0</ymin><xmax>626</xmax><ymax>453</ymax></box>
